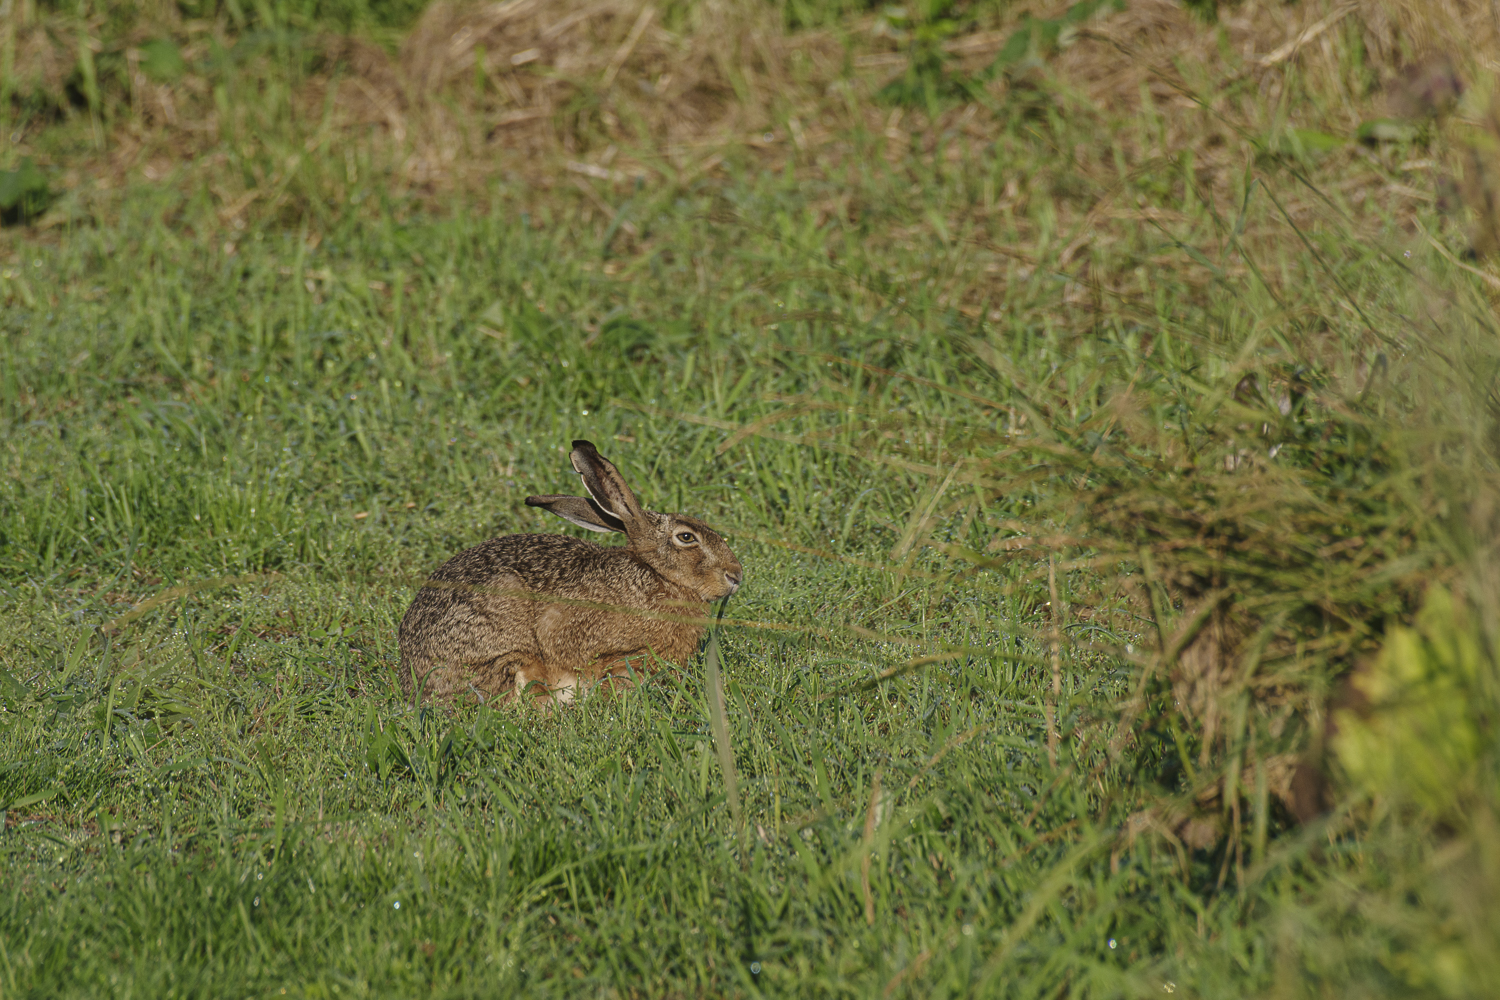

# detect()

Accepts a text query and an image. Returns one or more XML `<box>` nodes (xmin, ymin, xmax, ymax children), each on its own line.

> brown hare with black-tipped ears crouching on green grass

<box><xmin>401</xmin><ymin>441</ymin><xmax>743</xmax><ymax>703</ymax></box>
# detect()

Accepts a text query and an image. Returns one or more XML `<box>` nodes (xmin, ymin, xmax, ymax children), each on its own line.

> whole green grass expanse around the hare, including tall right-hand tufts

<box><xmin>0</xmin><ymin>1</ymin><xmax>1496</xmax><ymax>997</ymax></box>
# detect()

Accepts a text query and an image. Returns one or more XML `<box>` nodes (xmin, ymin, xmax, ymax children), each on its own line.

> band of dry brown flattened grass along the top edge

<box><xmin>5</xmin><ymin>0</ymin><xmax>1500</xmax><ymax>242</ymax></box>
